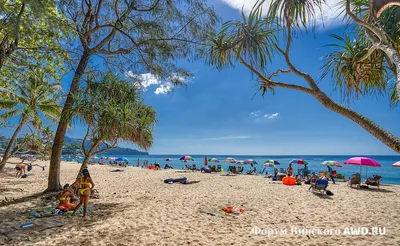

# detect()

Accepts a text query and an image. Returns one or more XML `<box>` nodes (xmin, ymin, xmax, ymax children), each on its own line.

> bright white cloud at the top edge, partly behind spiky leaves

<box><xmin>221</xmin><ymin>0</ymin><xmax>344</xmax><ymax>27</ymax></box>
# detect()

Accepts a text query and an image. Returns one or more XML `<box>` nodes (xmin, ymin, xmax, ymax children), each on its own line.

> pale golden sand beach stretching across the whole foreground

<box><xmin>0</xmin><ymin>159</ymin><xmax>400</xmax><ymax>246</ymax></box>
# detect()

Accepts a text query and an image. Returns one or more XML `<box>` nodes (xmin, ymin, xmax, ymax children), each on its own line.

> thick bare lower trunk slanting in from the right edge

<box><xmin>313</xmin><ymin>90</ymin><xmax>400</xmax><ymax>153</ymax></box>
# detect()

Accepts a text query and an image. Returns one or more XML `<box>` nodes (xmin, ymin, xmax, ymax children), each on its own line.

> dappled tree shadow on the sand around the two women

<box><xmin>0</xmin><ymin>202</ymin><xmax>127</xmax><ymax>245</ymax></box>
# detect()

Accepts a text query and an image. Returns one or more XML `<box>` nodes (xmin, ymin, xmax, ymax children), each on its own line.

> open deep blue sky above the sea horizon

<box><xmin>0</xmin><ymin>0</ymin><xmax>400</xmax><ymax>155</ymax></box>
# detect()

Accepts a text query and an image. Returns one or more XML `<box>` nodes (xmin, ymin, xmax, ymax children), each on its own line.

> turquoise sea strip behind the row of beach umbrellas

<box><xmin>65</xmin><ymin>155</ymin><xmax>400</xmax><ymax>184</ymax></box>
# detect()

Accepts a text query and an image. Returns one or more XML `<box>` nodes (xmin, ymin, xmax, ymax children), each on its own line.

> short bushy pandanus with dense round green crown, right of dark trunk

<box><xmin>74</xmin><ymin>73</ymin><xmax>156</xmax><ymax>173</ymax></box>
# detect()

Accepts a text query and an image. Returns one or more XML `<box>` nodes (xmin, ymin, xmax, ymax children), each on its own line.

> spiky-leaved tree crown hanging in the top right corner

<box><xmin>324</xmin><ymin>0</ymin><xmax>400</xmax><ymax>105</ymax></box>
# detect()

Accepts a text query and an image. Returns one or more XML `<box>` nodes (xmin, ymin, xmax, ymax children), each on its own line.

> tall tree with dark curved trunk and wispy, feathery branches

<box><xmin>47</xmin><ymin>0</ymin><xmax>217</xmax><ymax>191</ymax></box>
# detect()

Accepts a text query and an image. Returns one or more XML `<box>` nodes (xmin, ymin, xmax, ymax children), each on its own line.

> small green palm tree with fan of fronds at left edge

<box><xmin>0</xmin><ymin>70</ymin><xmax>61</xmax><ymax>170</ymax></box>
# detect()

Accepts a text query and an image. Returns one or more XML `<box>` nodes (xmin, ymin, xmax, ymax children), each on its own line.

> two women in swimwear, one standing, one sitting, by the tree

<box><xmin>57</xmin><ymin>168</ymin><xmax>94</xmax><ymax>217</ymax></box>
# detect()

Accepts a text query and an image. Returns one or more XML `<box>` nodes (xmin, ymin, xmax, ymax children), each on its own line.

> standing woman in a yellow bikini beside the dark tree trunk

<box><xmin>72</xmin><ymin>168</ymin><xmax>94</xmax><ymax>217</ymax></box>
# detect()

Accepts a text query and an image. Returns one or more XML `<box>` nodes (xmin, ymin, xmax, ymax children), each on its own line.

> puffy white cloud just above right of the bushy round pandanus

<box><xmin>125</xmin><ymin>71</ymin><xmax>187</xmax><ymax>95</ymax></box>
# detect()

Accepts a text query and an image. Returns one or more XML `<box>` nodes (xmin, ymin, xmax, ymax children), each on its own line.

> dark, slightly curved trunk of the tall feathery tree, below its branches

<box><xmin>46</xmin><ymin>51</ymin><xmax>90</xmax><ymax>192</ymax></box>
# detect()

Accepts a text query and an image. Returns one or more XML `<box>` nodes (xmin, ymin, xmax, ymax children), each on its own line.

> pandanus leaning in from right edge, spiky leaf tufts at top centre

<box><xmin>207</xmin><ymin>0</ymin><xmax>400</xmax><ymax>153</ymax></box>
